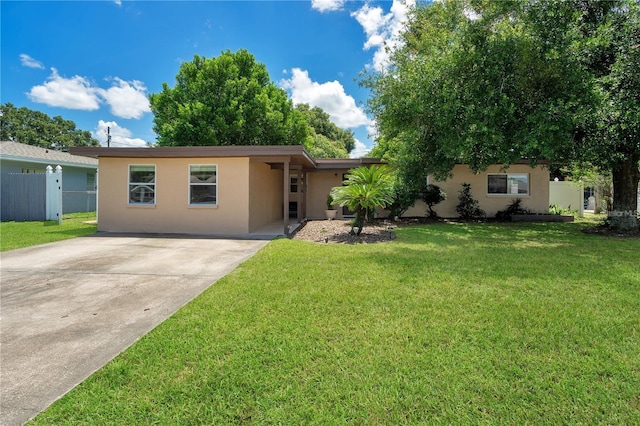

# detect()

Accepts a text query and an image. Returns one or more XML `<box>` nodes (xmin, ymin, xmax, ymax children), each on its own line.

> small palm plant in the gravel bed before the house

<box><xmin>331</xmin><ymin>164</ymin><xmax>394</xmax><ymax>235</ymax></box>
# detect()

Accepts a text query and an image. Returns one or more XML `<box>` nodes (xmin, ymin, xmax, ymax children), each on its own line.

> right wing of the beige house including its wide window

<box><xmin>405</xmin><ymin>164</ymin><xmax>549</xmax><ymax>218</ymax></box>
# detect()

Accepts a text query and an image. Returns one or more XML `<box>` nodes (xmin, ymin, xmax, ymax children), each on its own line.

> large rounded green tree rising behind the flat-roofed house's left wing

<box><xmin>149</xmin><ymin>49</ymin><xmax>308</xmax><ymax>146</ymax></box>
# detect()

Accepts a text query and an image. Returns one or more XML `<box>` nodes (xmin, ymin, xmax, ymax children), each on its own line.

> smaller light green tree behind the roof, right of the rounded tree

<box><xmin>295</xmin><ymin>104</ymin><xmax>355</xmax><ymax>158</ymax></box>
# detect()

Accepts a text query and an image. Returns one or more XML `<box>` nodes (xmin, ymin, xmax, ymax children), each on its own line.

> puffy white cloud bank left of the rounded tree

<box><xmin>27</xmin><ymin>68</ymin><xmax>151</xmax><ymax>119</ymax></box>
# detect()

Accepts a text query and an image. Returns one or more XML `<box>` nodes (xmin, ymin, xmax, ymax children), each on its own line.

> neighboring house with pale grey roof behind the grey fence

<box><xmin>0</xmin><ymin>141</ymin><xmax>98</xmax><ymax>218</ymax></box>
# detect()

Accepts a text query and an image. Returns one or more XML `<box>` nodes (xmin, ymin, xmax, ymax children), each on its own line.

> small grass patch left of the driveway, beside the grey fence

<box><xmin>0</xmin><ymin>212</ymin><xmax>97</xmax><ymax>251</ymax></box>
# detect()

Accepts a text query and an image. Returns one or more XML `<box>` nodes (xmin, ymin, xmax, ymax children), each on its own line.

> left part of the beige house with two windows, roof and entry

<box><xmin>72</xmin><ymin>146</ymin><xmax>381</xmax><ymax>235</ymax></box>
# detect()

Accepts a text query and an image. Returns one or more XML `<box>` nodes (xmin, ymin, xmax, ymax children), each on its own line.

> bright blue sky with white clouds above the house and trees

<box><xmin>0</xmin><ymin>0</ymin><xmax>411</xmax><ymax>156</ymax></box>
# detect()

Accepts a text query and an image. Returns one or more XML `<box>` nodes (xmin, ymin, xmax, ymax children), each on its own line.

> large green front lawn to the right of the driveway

<box><xmin>28</xmin><ymin>218</ymin><xmax>640</xmax><ymax>425</ymax></box>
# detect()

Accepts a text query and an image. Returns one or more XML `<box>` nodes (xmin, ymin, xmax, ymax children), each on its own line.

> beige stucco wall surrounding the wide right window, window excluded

<box><xmin>405</xmin><ymin>164</ymin><xmax>549</xmax><ymax>218</ymax></box>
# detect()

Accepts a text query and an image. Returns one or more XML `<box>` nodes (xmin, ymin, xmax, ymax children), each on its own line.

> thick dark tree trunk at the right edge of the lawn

<box><xmin>609</xmin><ymin>155</ymin><xmax>640</xmax><ymax>231</ymax></box>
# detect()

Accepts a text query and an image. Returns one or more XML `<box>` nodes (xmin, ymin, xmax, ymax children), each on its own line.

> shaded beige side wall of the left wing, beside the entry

<box><xmin>249</xmin><ymin>163</ymin><xmax>284</xmax><ymax>232</ymax></box>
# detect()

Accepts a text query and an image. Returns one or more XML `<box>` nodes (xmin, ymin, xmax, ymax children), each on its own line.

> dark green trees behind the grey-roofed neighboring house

<box><xmin>0</xmin><ymin>103</ymin><xmax>100</xmax><ymax>150</ymax></box>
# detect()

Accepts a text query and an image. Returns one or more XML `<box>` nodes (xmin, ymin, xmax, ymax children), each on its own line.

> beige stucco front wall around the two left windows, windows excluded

<box><xmin>98</xmin><ymin>157</ymin><xmax>249</xmax><ymax>235</ymax></box>
